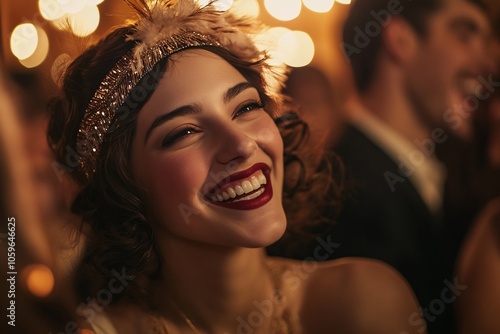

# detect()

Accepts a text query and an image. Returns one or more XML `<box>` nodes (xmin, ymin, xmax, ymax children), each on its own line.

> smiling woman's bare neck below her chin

<box><xmin>152</xmin><ymin>236</ymin><xmax>275</xmax><ymax>333</ymax></box>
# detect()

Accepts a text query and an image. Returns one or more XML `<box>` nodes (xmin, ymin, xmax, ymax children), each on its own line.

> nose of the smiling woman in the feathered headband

<box><xmin>216</xmin><ymin>125</ymin><xmax>257</xmax><ymax>164</ymax></box>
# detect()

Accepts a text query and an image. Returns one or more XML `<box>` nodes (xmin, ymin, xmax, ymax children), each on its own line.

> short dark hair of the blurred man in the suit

<box><xmin>341</xmin><ymin>0</ymin><xmax>486</xmax><ymax>92</ymax></box>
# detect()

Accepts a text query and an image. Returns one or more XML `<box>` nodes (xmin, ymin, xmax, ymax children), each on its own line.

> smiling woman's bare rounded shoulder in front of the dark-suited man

<box><xmin>268</xmin><ymin>258</ymin><xmax>425</xmax><ymax>334</ymax></box>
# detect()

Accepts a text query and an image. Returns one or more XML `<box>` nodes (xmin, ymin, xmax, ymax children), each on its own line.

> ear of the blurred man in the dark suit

<box><xmin>382</xmin><ymin>16</ymin><xmax>418</xmax><ymax>63</ymax></box>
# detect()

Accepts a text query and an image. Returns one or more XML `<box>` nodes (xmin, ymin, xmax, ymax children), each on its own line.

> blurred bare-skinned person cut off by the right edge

<box><xmin>457</xmin><ymin>66</ymin><xmax>500</xmax><ymax>334</ymax></box>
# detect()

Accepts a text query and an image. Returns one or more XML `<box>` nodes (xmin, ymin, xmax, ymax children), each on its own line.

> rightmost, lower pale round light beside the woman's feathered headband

<box><xmin>278</xmin><ymin>30</ymin><xmax>314</xmax><ymax>67</ymax></box>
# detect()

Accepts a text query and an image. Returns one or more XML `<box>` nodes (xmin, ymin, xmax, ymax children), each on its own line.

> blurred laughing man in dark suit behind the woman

<box><xmin>270</xmin><ymin>0</ymin><xmax>491</xmax><ymax>334</ymax></box>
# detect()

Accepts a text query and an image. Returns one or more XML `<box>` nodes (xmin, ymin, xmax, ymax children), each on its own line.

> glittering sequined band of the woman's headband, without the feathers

<box><xmin>77</xmin><ymin>32</ymin><xmax>221</xmax><ymax>178</ymax></box>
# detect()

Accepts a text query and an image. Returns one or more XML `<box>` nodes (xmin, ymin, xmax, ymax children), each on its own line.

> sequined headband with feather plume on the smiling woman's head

<box><xmin>77</xmin><ymin>0</ymin><xmax>285</xmax><ymax>179</ymax></box>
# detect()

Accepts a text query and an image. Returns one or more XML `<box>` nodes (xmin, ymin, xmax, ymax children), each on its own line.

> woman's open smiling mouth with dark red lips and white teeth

<box><xmin>205</xmin><ymin>163</ymin><xmax>273</xmax><ymax>210</ymax></box>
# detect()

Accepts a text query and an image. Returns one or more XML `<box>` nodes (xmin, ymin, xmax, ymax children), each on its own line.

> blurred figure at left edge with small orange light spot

<box><xmin>0</xmin><ymin>64</ymin><xmax>81</xmax><ymax>334</ymax></box>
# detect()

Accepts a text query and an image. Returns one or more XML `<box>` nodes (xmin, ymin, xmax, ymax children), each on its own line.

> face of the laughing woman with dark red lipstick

<box><xmin>132</xmin><ymin>49</ymin><xmax>286</xmax><ymax>247</ymax></box>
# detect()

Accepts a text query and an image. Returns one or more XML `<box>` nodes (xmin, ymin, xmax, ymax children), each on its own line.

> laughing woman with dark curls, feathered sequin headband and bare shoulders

<box><xmin>49</xmin><ymin>0</ymin><xmax>421</xmax><ymax>334</ymax></box>
